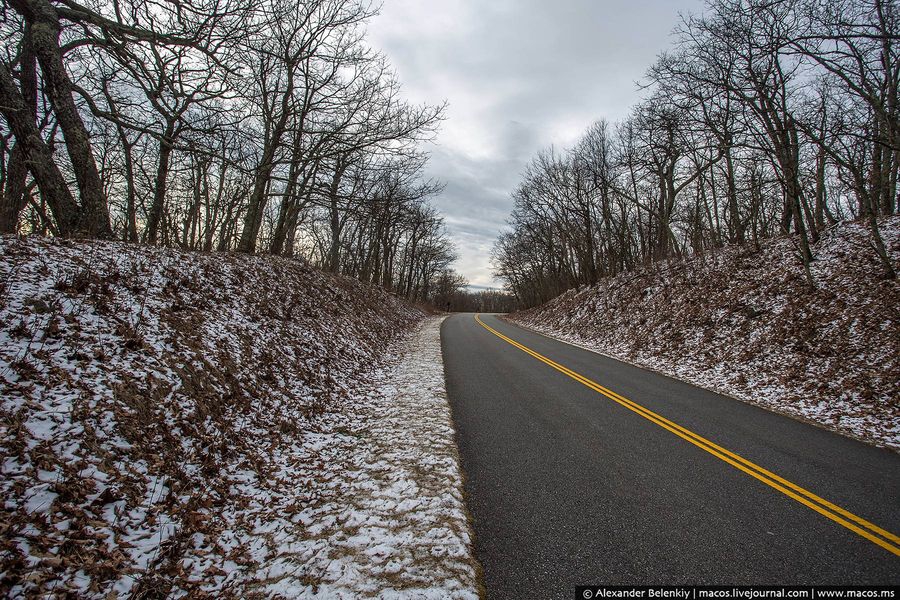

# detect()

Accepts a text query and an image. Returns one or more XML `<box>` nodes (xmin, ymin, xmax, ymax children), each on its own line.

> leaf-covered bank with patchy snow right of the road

<box><xmin>511</xmin><ymin>217</ymin><xmax>900</xmax><ymax>449</ymax></box>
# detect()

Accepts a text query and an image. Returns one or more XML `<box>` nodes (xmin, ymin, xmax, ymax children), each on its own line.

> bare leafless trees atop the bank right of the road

<box><xmin>493</xmin><ymin>0</ymin><xmax>900</xmax><ymax>306</ymax></box>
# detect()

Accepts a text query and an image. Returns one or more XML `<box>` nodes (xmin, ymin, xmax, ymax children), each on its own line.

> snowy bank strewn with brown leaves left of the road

<box><xmin>0</xmin><ymin>236</ymin><xmax>482</xmax><ymax>597</ymax></box>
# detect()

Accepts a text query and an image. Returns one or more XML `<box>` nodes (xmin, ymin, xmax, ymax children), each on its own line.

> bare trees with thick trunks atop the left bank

<box><xmin>0</xmin><ymin>0</ymin><xmax>454</xmax><ymax>300</ymax></box>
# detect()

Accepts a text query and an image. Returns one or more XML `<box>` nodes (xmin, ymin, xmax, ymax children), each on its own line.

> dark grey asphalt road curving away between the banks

<box><xmin>441</xmin><ymin>314</ymin><xmax>900</xmax><ymax>598</ymax></box>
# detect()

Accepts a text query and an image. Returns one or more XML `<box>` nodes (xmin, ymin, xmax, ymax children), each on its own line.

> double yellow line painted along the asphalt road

<box><xmin>475</xmin><ymin>315</ymin><xmax>900</xmax><ymax>556</ymax></box>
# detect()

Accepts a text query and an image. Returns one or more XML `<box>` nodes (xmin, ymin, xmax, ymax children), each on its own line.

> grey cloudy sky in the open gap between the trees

<box><xmin>369</xmin><ymin>0</ymin><xmax>702</xmax><ymax>287</ymax></box>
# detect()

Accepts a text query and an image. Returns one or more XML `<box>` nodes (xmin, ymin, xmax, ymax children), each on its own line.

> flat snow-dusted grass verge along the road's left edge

<box><xmin>253</xmin><ymin>317</ymin><xmax>478</xmax><ymax>599</ymax></box>
